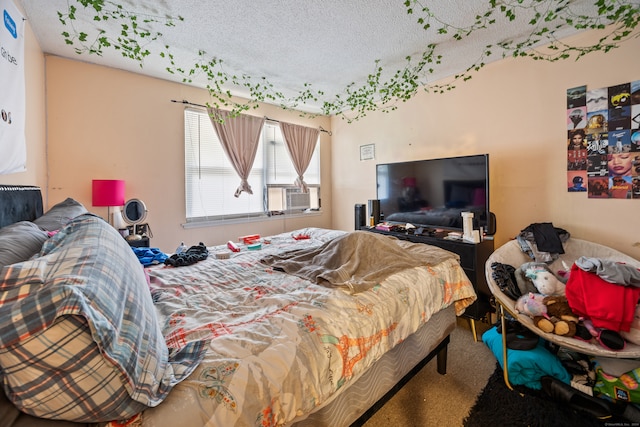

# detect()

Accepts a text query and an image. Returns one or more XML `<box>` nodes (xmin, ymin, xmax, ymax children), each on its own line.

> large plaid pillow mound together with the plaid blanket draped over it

<box><xmin>0</xmin><ymin>214</ymin><xmax>207</xmax><ymax>422</ymax></box>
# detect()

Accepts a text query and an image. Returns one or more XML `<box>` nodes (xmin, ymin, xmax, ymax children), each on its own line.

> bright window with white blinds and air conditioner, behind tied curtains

<box><xmin>184</xmin><ymin>109</ymin><xmax>320</xmax><ymax>222</ymax></box>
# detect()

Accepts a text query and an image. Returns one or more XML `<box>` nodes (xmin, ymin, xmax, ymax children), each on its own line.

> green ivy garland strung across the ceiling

<box><xmin>58</xmin><ymin>0</ymin><xmax>640</xmax><ymax>122</ymax></box>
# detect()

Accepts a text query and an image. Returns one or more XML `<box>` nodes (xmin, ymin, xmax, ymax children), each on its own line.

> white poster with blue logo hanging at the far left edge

<box><xmin>0</xmin><ymin>0</ymin><xmax>27</xmax><ymax>174</ymax></box>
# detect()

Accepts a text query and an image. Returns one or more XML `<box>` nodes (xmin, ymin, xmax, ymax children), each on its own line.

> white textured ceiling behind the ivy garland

<box><xmin>15</xmin><ymin>0</ymin><xmax>596</xmax><ymax>111</ymax></box>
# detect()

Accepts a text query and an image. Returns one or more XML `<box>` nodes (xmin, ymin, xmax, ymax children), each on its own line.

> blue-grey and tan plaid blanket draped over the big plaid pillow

<box><xmin>0</xmin><ymin>214</ymin><xmax>206</xmax><ymax>422</ymax></box>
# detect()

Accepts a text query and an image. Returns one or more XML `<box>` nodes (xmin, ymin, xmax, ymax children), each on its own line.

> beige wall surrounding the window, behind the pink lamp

<box><xmin>46</xmin><ymin>56</ymin><xmax>331</xmax><ymax>252</ymax></box>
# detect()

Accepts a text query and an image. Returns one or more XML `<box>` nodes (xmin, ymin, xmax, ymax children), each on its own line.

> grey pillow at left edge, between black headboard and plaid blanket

<box><xmin>0</xmin><ymin>221</ymin><xmax>49</xmax><ymax>270</ymax></box>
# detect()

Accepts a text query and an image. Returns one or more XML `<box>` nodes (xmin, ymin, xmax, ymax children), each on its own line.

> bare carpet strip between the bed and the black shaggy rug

<box><xmin>364</xmin><ymin>318</ymin><xmax>496</xmax><ymax>427</ymax></box>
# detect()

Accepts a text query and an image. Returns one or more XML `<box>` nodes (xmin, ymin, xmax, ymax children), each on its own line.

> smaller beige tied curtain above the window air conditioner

<box><xmin>280</xmin><ymin>122</ymin><xmax>320</xmax><ymax>193</ymax></box>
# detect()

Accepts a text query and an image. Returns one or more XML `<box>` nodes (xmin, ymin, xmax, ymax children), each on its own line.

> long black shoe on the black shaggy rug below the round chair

<box><xmin>540</xmin><ymin>375</ymin><xmax>612</xmax><ymax>420</ymax></box>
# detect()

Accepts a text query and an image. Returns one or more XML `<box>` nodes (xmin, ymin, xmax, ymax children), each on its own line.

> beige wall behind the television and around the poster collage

<box><xmin>332</xmin><ymin>30</ymin><xmax>640</xmax><ymax>259</ymax></box>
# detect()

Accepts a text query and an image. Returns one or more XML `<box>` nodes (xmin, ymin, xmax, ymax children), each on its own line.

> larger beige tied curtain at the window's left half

<box><xmin>207</xmin><ymin>108</ymin><xmax>264</xmax><ymax>197</ymax></box>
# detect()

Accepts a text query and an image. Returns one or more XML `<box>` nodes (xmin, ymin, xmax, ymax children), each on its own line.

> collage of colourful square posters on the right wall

<box><xmin>566</xmin><ymin>80</ymin><xmax>640</xmax><ymax>200</ymax></box>
